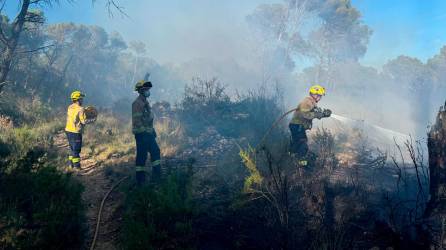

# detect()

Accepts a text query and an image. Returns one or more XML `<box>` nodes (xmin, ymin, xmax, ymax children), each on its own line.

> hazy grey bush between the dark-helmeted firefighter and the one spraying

<box><xmin>179</xmin><ymin>78</ymin><xmax>282</xmax><ymax>142</ymax></box>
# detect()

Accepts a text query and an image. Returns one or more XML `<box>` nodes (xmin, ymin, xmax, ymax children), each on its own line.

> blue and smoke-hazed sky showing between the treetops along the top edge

<box><xmin>3</xmin><ymin>0</ymin><xmax>446</xmax><ymax>66</ymax></box>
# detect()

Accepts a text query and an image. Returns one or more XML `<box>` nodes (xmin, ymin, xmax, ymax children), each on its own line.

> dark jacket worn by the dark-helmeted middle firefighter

<box><xmin>132</xmin><ymin>95</ymin><xmax>154</xmax><ymax>134</ymax></box>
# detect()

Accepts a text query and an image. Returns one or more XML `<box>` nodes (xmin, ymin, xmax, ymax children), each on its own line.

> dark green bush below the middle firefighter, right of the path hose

<box><xmin>122</xmin><ymin>171</ymin><xmax>196</xmax><ymax>249</ymax></box>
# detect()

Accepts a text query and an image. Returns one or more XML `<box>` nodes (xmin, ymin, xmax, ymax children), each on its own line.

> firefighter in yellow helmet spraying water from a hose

<box><xmin>289</xmin><ymin>85</ymin><xmax>331</xmax><ymax>166</ymax></box>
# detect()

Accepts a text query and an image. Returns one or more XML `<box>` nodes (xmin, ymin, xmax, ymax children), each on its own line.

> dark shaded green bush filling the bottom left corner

<box><xmin>0</xmin><ymin>149</ymin><xmax>85</xmax><ymax>249</ymax></box>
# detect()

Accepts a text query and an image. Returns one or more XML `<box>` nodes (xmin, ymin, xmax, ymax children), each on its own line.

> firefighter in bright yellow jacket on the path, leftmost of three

<box><xmin>65</xmin><ymin>91</ymin><xmax>88</xmax><ymax>169</ymax></box>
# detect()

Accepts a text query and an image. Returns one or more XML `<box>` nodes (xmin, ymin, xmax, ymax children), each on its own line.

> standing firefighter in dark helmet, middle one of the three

<box><xmin>132</xmin><ymin>80</ymin><xmax>161</xmax><ymax>185</ymax></box>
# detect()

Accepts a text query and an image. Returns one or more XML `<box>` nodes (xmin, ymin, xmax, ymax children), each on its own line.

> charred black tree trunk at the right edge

<box><xmin>425</xmin><ymin>100</ymin><xmax>446</xmax><ymax>249</ymax></box>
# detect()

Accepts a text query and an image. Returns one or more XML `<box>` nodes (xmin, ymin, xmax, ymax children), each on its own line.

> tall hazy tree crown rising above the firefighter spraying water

<box><xmin>248</xmin><ymin>0</ymin><xmax>371</xmax><ymax>83</ymax></box>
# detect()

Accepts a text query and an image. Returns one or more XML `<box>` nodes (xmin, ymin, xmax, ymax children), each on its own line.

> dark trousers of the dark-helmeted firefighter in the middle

<box><xmin>135</xmin><ymin>132</ymin><xmax>161</xmax><ymax>183</ymax></box>
